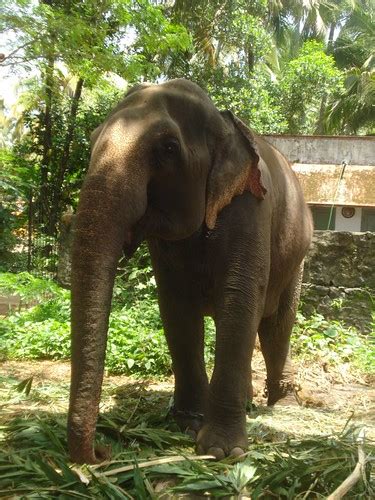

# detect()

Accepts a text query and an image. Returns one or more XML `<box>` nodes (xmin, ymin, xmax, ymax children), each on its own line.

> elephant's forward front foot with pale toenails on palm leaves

<box><xmin>197</xmin><ymin>423</ymin><xmax>247</xmax><ymax>460</ymax></box>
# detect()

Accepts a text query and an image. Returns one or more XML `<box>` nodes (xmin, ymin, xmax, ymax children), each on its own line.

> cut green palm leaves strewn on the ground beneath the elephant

<box><xmin>0</xmin><ymin>370</ymin><xmax>375</xmax><ymax>499</ymax></box>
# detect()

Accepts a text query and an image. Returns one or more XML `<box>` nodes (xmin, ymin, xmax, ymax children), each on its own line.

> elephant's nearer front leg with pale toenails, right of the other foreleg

<box><xmin>197</xmin><ymin>286</ymin><xmax>259</xmax><ymax>459</ymax></box>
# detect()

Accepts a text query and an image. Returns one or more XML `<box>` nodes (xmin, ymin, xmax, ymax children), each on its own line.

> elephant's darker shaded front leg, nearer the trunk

<box><xmin>159</xmin><ymin>289</ymin><xmax>208</xmax><ymax>437</ymax></box>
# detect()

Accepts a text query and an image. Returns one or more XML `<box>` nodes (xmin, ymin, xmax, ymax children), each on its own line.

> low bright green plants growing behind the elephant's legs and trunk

<box><xmin>0</xmin><ymin>274</ymin><xmax>375</xmax><ymax>376</ymax></box>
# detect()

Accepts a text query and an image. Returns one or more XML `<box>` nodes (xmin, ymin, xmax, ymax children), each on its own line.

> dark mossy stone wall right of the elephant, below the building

<box><xmin>301</xmin><ymin>231</ymin><xmax>375</xmax><ymax>333</ymax></box>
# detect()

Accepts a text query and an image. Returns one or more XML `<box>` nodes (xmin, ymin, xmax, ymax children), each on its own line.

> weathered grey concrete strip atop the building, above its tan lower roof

<box><xmin>264</xmin><ymin>135</ymin><xmax>375</xmax><ymax>165</ymax></box>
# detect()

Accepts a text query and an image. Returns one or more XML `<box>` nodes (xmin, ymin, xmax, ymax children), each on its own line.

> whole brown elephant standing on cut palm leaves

<box><xmin>68</xmin><ymin>79</ymin><xmax>312</xmax><ymax>463</ymax></box>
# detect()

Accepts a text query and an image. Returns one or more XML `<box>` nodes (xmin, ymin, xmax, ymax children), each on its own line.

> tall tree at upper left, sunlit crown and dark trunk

<box><xmin>2</xmin><ymin>0</ymin><xmax>190</xmax><ymax>235</ymax></box>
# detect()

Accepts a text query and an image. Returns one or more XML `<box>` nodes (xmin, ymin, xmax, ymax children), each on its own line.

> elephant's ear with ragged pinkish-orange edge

<box><xmin>206</xmin><ymin>111</ymin><xmax>267</xmax><ymax>229</ymax></box>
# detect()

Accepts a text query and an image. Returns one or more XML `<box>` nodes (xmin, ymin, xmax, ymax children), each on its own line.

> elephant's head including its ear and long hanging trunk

<box><xmin>68</xmin><ymin>80</ymin><xmax>265</xmax><ymax>463</ymax></box>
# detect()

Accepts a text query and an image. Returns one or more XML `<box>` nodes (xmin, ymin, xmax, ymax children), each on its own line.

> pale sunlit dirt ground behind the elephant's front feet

<box><xmin>0</xmin><ymin>352</ymin><xmax>375</xmax><ymax>440</ymax></box>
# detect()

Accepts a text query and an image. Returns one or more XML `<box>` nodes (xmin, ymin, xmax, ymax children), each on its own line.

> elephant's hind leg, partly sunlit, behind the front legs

<box><xmin>259</xmin><ymin>266</ymin><xmax>303</xmax><ymax>405</ymax></box>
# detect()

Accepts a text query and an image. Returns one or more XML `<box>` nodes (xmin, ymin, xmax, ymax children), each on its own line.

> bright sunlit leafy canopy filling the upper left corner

<box><xmin>1</xmin><ymin>0</ymin><xmax>190</xmax><ymax>87</ymax></box>
